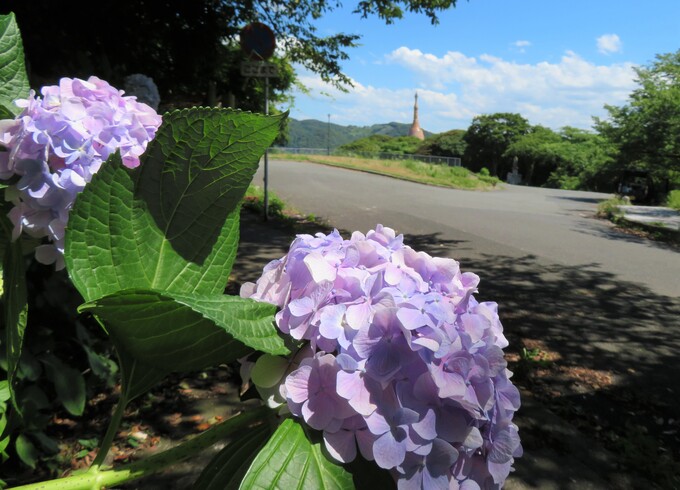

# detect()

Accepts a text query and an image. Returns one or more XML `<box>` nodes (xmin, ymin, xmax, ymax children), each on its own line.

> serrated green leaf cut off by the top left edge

<box><xmin>0</xmin><ymin>13</ymin><xmax>30</xmax><ymax>115</ymax></box>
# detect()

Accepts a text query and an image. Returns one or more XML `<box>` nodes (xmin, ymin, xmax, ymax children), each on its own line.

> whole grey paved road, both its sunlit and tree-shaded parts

<box><xmin>254</xmin><ymin>161</ymin><xmax>680</xmax><ymax>489</ymax></box>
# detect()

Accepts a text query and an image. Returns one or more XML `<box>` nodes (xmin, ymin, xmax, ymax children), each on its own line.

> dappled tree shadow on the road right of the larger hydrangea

<box><xmin>465</xmin><ymin>255</ymin><xmax>680</xmax><ymax>380</ymax></box>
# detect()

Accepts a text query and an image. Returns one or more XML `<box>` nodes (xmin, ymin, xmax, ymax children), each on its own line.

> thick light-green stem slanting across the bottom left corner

<box><xmin>9</xmin><ymin>407</ymin><xmax>272</xmax><ymax>490</ymax></box>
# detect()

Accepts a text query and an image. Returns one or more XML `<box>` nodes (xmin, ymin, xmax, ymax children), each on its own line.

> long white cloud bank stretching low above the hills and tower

<box><xmin>292</xmin><ymin>47</ymin><xmax>635</xmax><ymax>132</ymax></box>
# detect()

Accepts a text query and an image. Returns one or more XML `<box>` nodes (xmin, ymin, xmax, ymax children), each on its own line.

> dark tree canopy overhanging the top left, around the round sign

<box><xmin>0</xmin><ymin>0</ymin><xmax>457</xmax><ymax>107</ymax></box>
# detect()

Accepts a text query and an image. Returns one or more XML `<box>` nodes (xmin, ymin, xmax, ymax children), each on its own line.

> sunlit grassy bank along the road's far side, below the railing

<box><xmin>274</xmin><ymin>153</ymin><xmax>500</xmax><ymax>190</ymax></box>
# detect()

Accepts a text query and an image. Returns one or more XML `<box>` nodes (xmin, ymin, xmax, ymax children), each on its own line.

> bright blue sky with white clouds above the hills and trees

<box><xmin>291</xmin><ymin>0</ymin><xmax>680</xmax><ymax>132</ymax></box>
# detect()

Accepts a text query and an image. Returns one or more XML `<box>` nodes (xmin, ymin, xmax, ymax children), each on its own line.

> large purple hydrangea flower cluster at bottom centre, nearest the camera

<box><xmin>241</xmin><ymin>225</ymin><xmax>522</xmax><ymax>490</ymax></box>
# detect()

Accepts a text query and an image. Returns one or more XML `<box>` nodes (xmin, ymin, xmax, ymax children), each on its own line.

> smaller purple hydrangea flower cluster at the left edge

<box><xmin>0</xmin><ymin>77</ymin><xmax>161</xmax><ymax>268</ymax></box>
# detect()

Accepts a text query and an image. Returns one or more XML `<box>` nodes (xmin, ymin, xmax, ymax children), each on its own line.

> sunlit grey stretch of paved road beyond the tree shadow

<box><xmin>255</xmin><ymin>161</ymin><xmax>680</xmax><ymax>296</ymax></box>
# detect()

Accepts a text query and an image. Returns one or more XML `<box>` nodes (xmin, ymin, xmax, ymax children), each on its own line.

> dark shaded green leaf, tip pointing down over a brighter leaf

<box><xmin>135</xmin><ymin>108</ymin><xmax>282</xmax><ymax>270</ymax></box>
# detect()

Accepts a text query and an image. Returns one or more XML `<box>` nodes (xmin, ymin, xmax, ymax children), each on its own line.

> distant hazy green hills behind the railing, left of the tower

<box><xmin>286</xmin><ymin>119</ymin><xmax>434</xmax><ymax>148</ymax></box>
